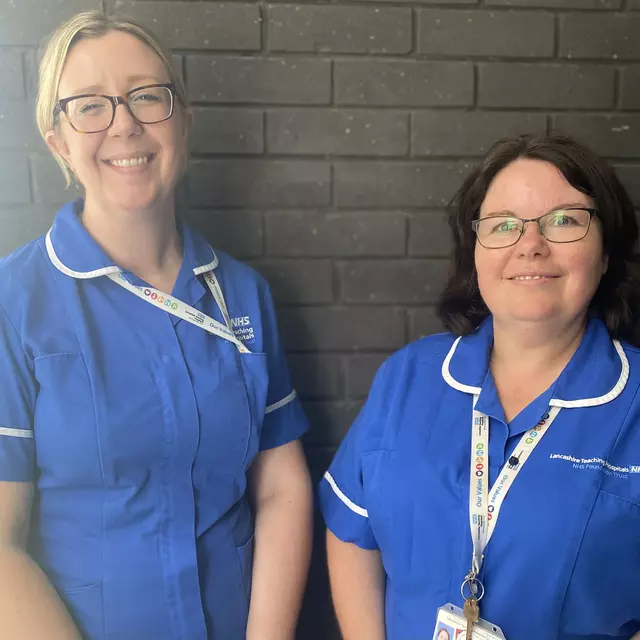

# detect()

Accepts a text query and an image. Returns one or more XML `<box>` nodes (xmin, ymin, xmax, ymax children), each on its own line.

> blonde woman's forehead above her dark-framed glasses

<box><xmin>58</xmin><ymin>31</ymin><xmax>169</xmax><ymax>97</ymax></box>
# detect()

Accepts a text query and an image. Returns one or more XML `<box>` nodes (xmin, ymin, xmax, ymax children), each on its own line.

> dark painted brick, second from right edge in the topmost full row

<box><xmin>418</xmin><ymin>9</ymin><xmax>555</xmax><ymax>58</ymax></box>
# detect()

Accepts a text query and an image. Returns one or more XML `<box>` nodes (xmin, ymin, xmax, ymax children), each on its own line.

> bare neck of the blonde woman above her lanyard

<box><xmin>82</xmin><ymin>199</ymin><xmax>182</xmax><ymax>286</ymax></box>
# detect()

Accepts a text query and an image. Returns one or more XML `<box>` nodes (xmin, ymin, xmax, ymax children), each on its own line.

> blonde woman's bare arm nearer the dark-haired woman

<box><xmin>247</xmin><ymin>440</ymin><xmax>312</xmax><ymax>640</ymax></box>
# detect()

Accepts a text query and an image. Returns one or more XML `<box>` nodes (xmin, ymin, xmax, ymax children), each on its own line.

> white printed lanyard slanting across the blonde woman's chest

<box><xmin>107</xmin><ymin>271</ymin><xmax>251</xmax><ymax>353</ymax></box>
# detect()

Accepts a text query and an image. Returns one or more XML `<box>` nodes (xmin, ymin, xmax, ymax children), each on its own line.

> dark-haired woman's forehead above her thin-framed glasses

<box><xmin>481</xmin><ymin>158</ymin><xmax>591</xmax><ymax>217</ymax></box>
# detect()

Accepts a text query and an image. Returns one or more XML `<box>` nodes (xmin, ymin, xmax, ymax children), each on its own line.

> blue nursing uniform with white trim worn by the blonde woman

<box><xmin>0</xmin><ymin>201</ymin><xmax>307</xmax><ymax>640</ymax></box>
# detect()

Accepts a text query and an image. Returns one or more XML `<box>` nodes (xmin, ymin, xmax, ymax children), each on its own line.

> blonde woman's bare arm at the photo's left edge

<box><xmin>0</xmin><ymin>482</ymin><xmax>81</xmax><ymax>640</ymax></box>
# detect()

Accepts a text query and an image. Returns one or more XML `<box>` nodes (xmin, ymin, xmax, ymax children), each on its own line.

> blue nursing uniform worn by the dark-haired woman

<box><xmin>320</xmin><ymin>318</ymin><xmax>640</xmax><ymax>640</ymax></box>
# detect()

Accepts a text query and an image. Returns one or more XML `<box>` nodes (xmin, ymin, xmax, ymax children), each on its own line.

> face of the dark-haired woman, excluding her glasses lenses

<box><xmin>475</xmin><ymin>159</ymin><xmax>607</xmax><ymax>324</ymax></box>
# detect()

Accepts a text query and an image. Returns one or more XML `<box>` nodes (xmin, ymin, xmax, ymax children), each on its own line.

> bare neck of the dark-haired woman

<box><xmin>491</xmin><ymin>317</ymin><xmax>586</xmax><ymax>379</ymax></box>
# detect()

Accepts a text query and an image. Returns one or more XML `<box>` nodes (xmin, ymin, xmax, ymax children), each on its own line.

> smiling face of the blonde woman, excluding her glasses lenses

<box><xmin>47</xmin><ymin>31</ymin><xmax>188</xmax><ymax>216</ymax></box>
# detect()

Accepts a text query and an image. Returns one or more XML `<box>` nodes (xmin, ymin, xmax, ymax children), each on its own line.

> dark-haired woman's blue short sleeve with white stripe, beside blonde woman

<box><xmin>319</xmin><ymin>364</ymin><xmax>386</xmax><ymax>549</ymax></box>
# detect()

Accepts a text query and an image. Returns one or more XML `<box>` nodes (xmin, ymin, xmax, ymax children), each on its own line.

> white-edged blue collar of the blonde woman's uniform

<box><xmin>45</xmin><ymin>198</ymin><xmax>218</xmax><ymax>280</ymax></box>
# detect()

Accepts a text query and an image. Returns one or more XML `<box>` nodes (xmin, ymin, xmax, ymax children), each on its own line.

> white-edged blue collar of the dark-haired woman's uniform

<box><xmin>442</xmin><ymin>316</ymin><xmax>629</xmax><ymax>408</ymax></box>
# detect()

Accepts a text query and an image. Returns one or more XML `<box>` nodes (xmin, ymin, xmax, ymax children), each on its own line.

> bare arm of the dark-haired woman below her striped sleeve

<box><xmin>327</xmin><ymin>530</ymin><xmax>386</xmax><ymax>640</ymax></box>
